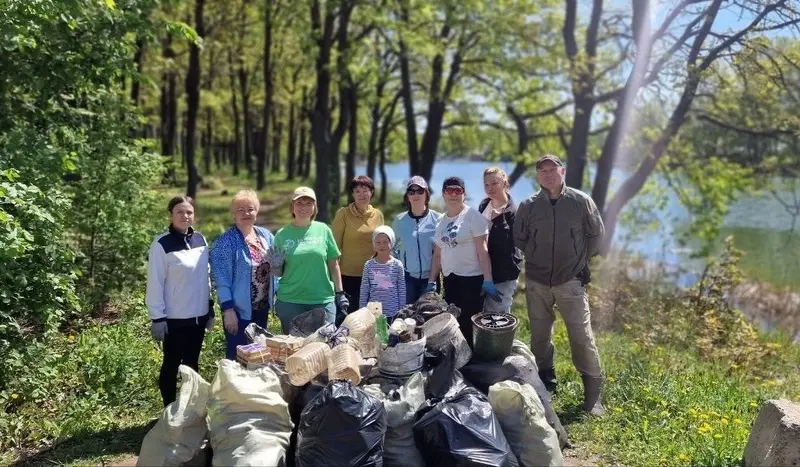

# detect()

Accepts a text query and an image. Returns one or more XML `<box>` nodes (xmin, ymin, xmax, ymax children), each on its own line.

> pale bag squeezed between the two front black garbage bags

<box><xmin>361</xmin><ymin>373</ymin><xmax>425</xmax><ymax>467</ymax></box>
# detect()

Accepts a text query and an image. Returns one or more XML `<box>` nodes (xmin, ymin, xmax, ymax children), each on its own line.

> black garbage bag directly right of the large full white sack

<box><xmin>295</xmin><ymin>381</ymin><xmax>386</xmax><ymax>467</ymax></box>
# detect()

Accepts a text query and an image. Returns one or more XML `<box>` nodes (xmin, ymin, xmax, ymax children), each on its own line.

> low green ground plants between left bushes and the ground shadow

<box><xmin>0</xmin><ymin>295</ymin><xmax>161</xmax><ymax>451</ymax></box>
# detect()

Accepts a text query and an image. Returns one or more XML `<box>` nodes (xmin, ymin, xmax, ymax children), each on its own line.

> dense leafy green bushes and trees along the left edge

<box><xmin>0</xmin><ymin>0</ymin><xmax>160</xmax><ymax>314</ymax></box>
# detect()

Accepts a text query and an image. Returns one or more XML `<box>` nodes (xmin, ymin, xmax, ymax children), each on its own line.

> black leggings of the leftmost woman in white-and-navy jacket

<box><xmin>158</xmin><ymin>316</ymin><xmax>208</xmax><ymax>407</ymax></box>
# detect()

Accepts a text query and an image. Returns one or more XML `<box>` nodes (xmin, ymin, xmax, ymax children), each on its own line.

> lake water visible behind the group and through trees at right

<box><xmin>358</xmin><ymin>161</ymin><xmax>800</xmax><ymax>285</ymax></box>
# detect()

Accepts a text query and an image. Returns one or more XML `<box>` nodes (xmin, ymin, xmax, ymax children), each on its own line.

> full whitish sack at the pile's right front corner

<box><xmin>489</xmin><ymin>381</ymin><xmax>564</xmax><ymax>467</ymax></box>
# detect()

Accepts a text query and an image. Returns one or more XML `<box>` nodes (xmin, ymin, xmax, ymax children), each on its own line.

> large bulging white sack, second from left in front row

<box><xmin>208</xmin><ymin>359</ymin><xmax>292</xmax><ymax>467</ymax></box>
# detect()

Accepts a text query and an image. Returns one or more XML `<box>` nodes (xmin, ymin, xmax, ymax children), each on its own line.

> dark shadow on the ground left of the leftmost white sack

<box><xmin>11</xmin><ymin>419</ymin><xmax>157</xmax><ymax>467</ymax></box>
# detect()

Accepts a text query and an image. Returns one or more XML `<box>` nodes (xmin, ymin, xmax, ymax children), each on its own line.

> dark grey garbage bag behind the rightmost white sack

<box><xmin>460</xmin><ymin>354</ymin><xmax>570</xmax><ymax>449</ymax></box>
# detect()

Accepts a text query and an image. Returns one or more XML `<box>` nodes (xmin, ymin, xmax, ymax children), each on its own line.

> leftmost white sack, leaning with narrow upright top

<box><xmin>136</xmin><ymin>365</ymin><xmax>211</xmax><ymax>467</ymax></box>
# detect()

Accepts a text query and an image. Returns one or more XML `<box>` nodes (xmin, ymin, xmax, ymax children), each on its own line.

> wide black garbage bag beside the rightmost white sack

<box><xmin>414</xmin><ymin>386</ymin><xmax>519</xmax><ymax>467</ymax></box>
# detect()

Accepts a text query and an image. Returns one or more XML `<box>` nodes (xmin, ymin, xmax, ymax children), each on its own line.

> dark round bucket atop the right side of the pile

<box><xmin>472</xmin><ymin>312</ymin><xmax>518</xmax><ymax>362</ymax></box>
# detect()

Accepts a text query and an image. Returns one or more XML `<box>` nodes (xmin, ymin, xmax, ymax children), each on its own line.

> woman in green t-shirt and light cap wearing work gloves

<box><xmin>268</xmin><ymin>186</ymin><xmax>349</xmax><ymax>334</ymax></box>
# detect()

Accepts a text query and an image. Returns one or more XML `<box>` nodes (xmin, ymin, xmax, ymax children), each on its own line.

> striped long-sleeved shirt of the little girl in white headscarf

<box><xmin>358</xmin><ymin>258</ymin><xmax>406</xmax><ymax>317</ymax></box>
